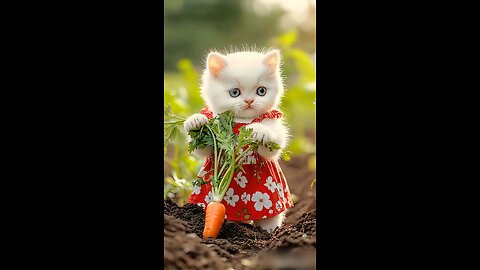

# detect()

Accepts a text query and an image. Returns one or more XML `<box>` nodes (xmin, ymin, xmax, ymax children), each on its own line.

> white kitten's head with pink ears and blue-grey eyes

<box><xmin>201</xmin><ymin>50</ymin><xmax>283</xmax><ymax>118</ymax></box>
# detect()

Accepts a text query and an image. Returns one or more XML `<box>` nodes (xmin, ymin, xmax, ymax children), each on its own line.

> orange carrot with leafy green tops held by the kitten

<box><xmin>164</xmin><ymin>106</ymin><xmax>289</xmax><ymax>239</ymax></box>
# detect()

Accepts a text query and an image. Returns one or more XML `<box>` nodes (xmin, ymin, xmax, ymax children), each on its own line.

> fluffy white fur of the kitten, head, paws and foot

<box><xmin>185</xmin><ymin>50</ymin><xmax>288</xmax><ymax>232</ymax></box>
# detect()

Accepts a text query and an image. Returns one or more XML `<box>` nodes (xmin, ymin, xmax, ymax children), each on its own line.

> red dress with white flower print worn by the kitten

<box><xmin>188</xmin><ymin>108</ymin><xmax>293</xmax><ymax>221</ymax></box>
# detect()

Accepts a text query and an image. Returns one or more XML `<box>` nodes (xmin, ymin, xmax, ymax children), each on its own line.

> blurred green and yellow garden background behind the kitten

<box><xmin>164</xmin><ymin>0</ymin><xmax>316</xmax><ymax>205</ymax></box>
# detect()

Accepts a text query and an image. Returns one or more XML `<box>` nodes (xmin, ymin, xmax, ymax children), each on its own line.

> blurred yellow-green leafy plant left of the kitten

<box><xmin>163</xmin><ymin>59</ymin><xmax>203</xmax><ymax>205</ymax></box>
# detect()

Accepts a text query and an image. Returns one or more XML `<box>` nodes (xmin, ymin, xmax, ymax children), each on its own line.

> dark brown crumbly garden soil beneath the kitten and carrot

<box><xmin>164</xmin><ymin>155</ymin><xmax>316</xmax><ymax>270</ymax></box>
